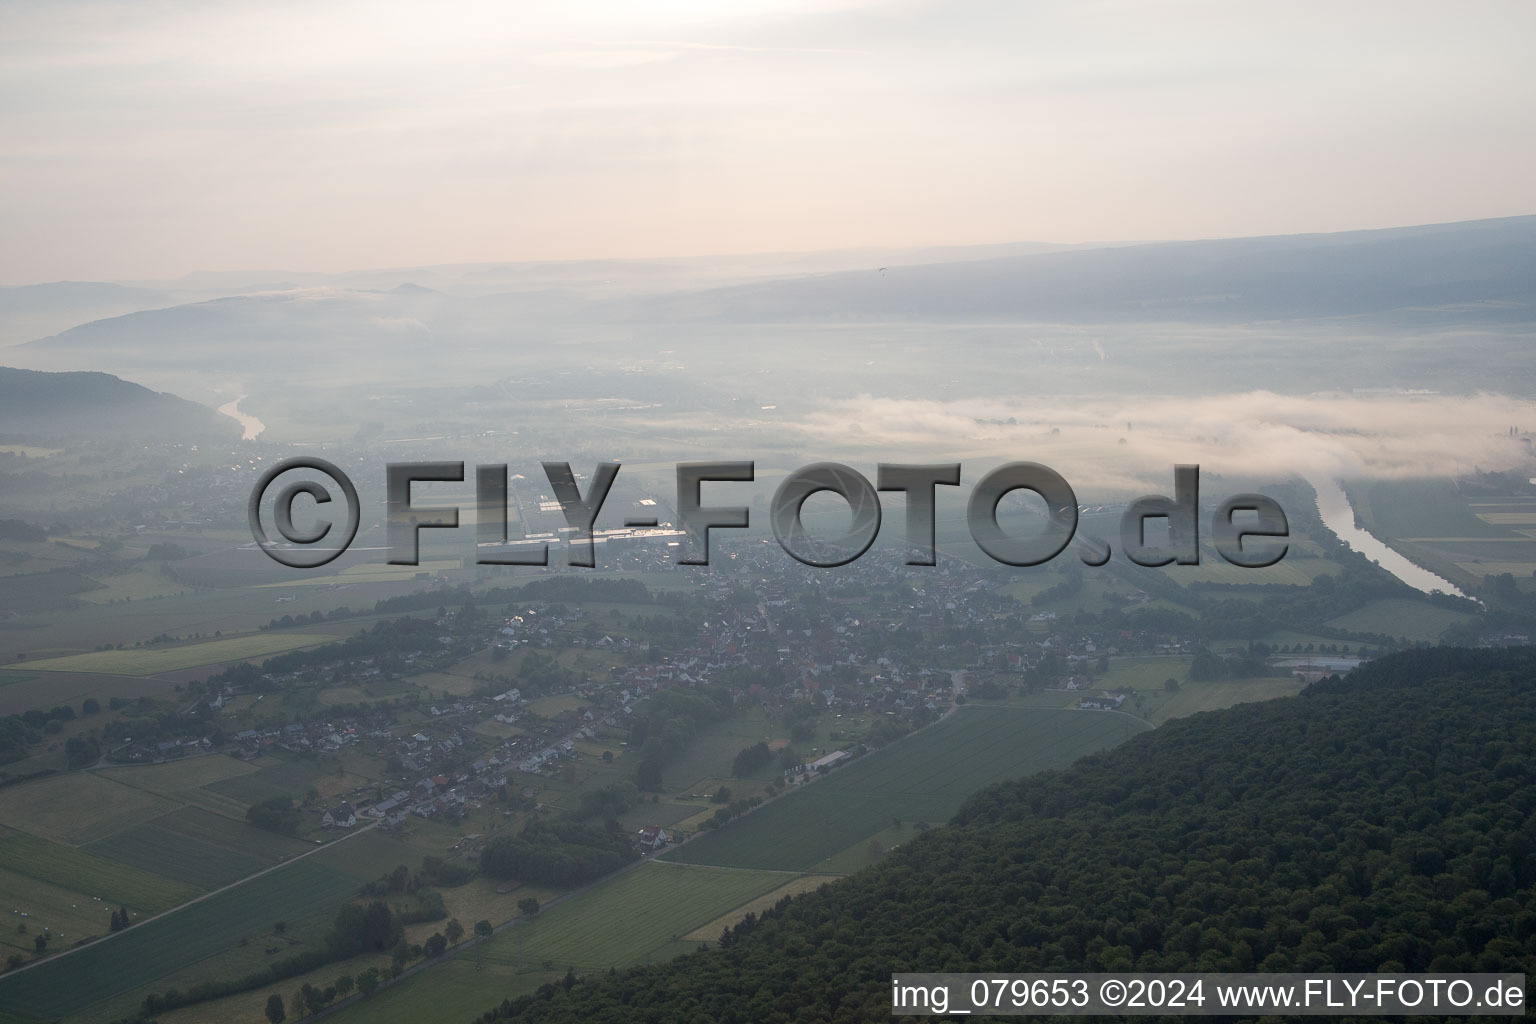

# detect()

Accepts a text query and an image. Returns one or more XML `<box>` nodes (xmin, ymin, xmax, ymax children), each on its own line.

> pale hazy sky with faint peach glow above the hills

<box><xmin>0</xmin><ymin>0</ymin><xmax>1536</xmax><ymax>284</ymax></box>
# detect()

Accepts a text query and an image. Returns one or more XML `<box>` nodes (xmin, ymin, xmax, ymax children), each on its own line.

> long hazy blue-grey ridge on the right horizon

<box><xmin>641</xmin><ymin>216</ymin><xmax>1536</xmax><ymax>325</ymax></box>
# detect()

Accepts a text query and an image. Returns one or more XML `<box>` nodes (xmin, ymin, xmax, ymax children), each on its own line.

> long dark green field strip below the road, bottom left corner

<box><xmin>0</xmin><ymin>861</ymin><xmax>358</xmax><ymax>1018</ymax></box>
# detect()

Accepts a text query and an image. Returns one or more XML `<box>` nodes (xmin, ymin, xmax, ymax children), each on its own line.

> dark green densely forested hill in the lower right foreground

<box><xmin>465</xmin><ymin>649</ymin><xmax>1536</xmax><ymax>1024</ymax></box>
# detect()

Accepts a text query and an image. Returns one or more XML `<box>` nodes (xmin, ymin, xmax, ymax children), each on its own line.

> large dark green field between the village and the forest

<box><xmin>665</xmin><ymin>708</ymin><xmax>1147</xmax><ymax>870</ymax></box>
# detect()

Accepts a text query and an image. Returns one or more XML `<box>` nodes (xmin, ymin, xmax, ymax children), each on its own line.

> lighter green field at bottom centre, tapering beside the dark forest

<box><xmin>317</xmin><ymin>861</ymin><xmax>791</xmax><ymax>1024</ymax></box>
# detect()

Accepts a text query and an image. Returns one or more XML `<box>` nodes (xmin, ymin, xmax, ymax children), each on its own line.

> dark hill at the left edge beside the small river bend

<box><xmin>0</xmin><ymin>367</ymin><xmax>240</xmax><ymax>444</ymax></box>
